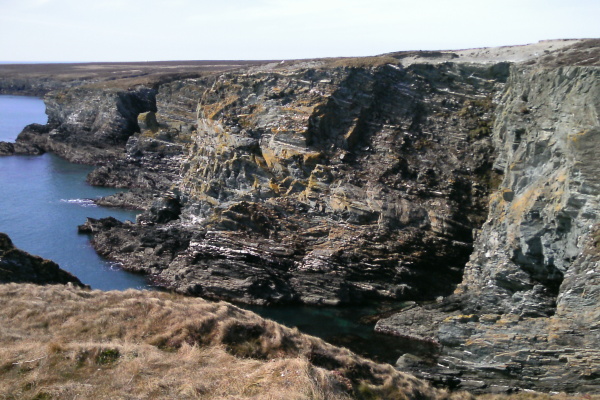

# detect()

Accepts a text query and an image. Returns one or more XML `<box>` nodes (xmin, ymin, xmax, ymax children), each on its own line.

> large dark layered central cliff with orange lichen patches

<box><xmin>83</xmin><ymin>64</ymin><xmax>508</xmax><ymax>304</ymax></box>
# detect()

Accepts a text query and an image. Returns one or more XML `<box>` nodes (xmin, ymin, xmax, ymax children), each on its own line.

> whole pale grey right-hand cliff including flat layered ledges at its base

<box><xmin>377</xmin><ymin>67</ymin><xmax>600</xmax><ymax>392</ymax></box>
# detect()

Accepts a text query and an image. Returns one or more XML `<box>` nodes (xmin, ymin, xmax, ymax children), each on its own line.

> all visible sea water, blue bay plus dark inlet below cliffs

<box><xmin>0</xmin><ymin>95</ymin><xmax>408</xmax><ymax>363</ymax></box>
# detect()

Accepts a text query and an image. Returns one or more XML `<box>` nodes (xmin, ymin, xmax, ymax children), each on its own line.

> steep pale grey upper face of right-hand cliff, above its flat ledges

<box><xmin>461</xmin><ymin>67</ymin><xmax>600</xmax><ymax>317</ymax></box>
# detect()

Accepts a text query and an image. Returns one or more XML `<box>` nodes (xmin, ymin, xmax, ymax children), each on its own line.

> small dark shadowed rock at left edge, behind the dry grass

<box><xmin>0</xmin><ymin>233</ymin><xmax>88</xmax><ymax>287</ymax></box>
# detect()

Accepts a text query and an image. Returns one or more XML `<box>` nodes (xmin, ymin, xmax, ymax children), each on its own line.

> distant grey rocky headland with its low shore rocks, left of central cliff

<box><xmin>13</xmin><ymin>86</ymin><xmax>195</xmax><ymax>209</ymax></box>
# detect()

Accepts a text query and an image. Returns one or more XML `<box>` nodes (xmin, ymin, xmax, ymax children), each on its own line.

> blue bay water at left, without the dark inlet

<box><xmin>0</xmin><ymin>96</ymin><xmax>150</xmax><ymax>290</ymax></box>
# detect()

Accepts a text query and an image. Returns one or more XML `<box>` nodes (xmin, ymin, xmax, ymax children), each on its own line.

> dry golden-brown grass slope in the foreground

<box><xmin>0</xmin><ymin>284</ymin><xmax>469</xmax><ymax>400</ymax></box>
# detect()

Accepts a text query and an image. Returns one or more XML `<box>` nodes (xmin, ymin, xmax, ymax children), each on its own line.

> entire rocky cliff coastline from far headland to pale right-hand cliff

<box><xmin>0</xmin><ymin>40</ymin><xmax>600</xmax><ymax>393</ymax></box>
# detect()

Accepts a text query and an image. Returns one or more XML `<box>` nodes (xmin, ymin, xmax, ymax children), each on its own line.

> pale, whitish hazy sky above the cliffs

<box><xmin>0</xmin><ymin>0</ymin><xmax>600</xmax><ymax>62</ymax></box>
